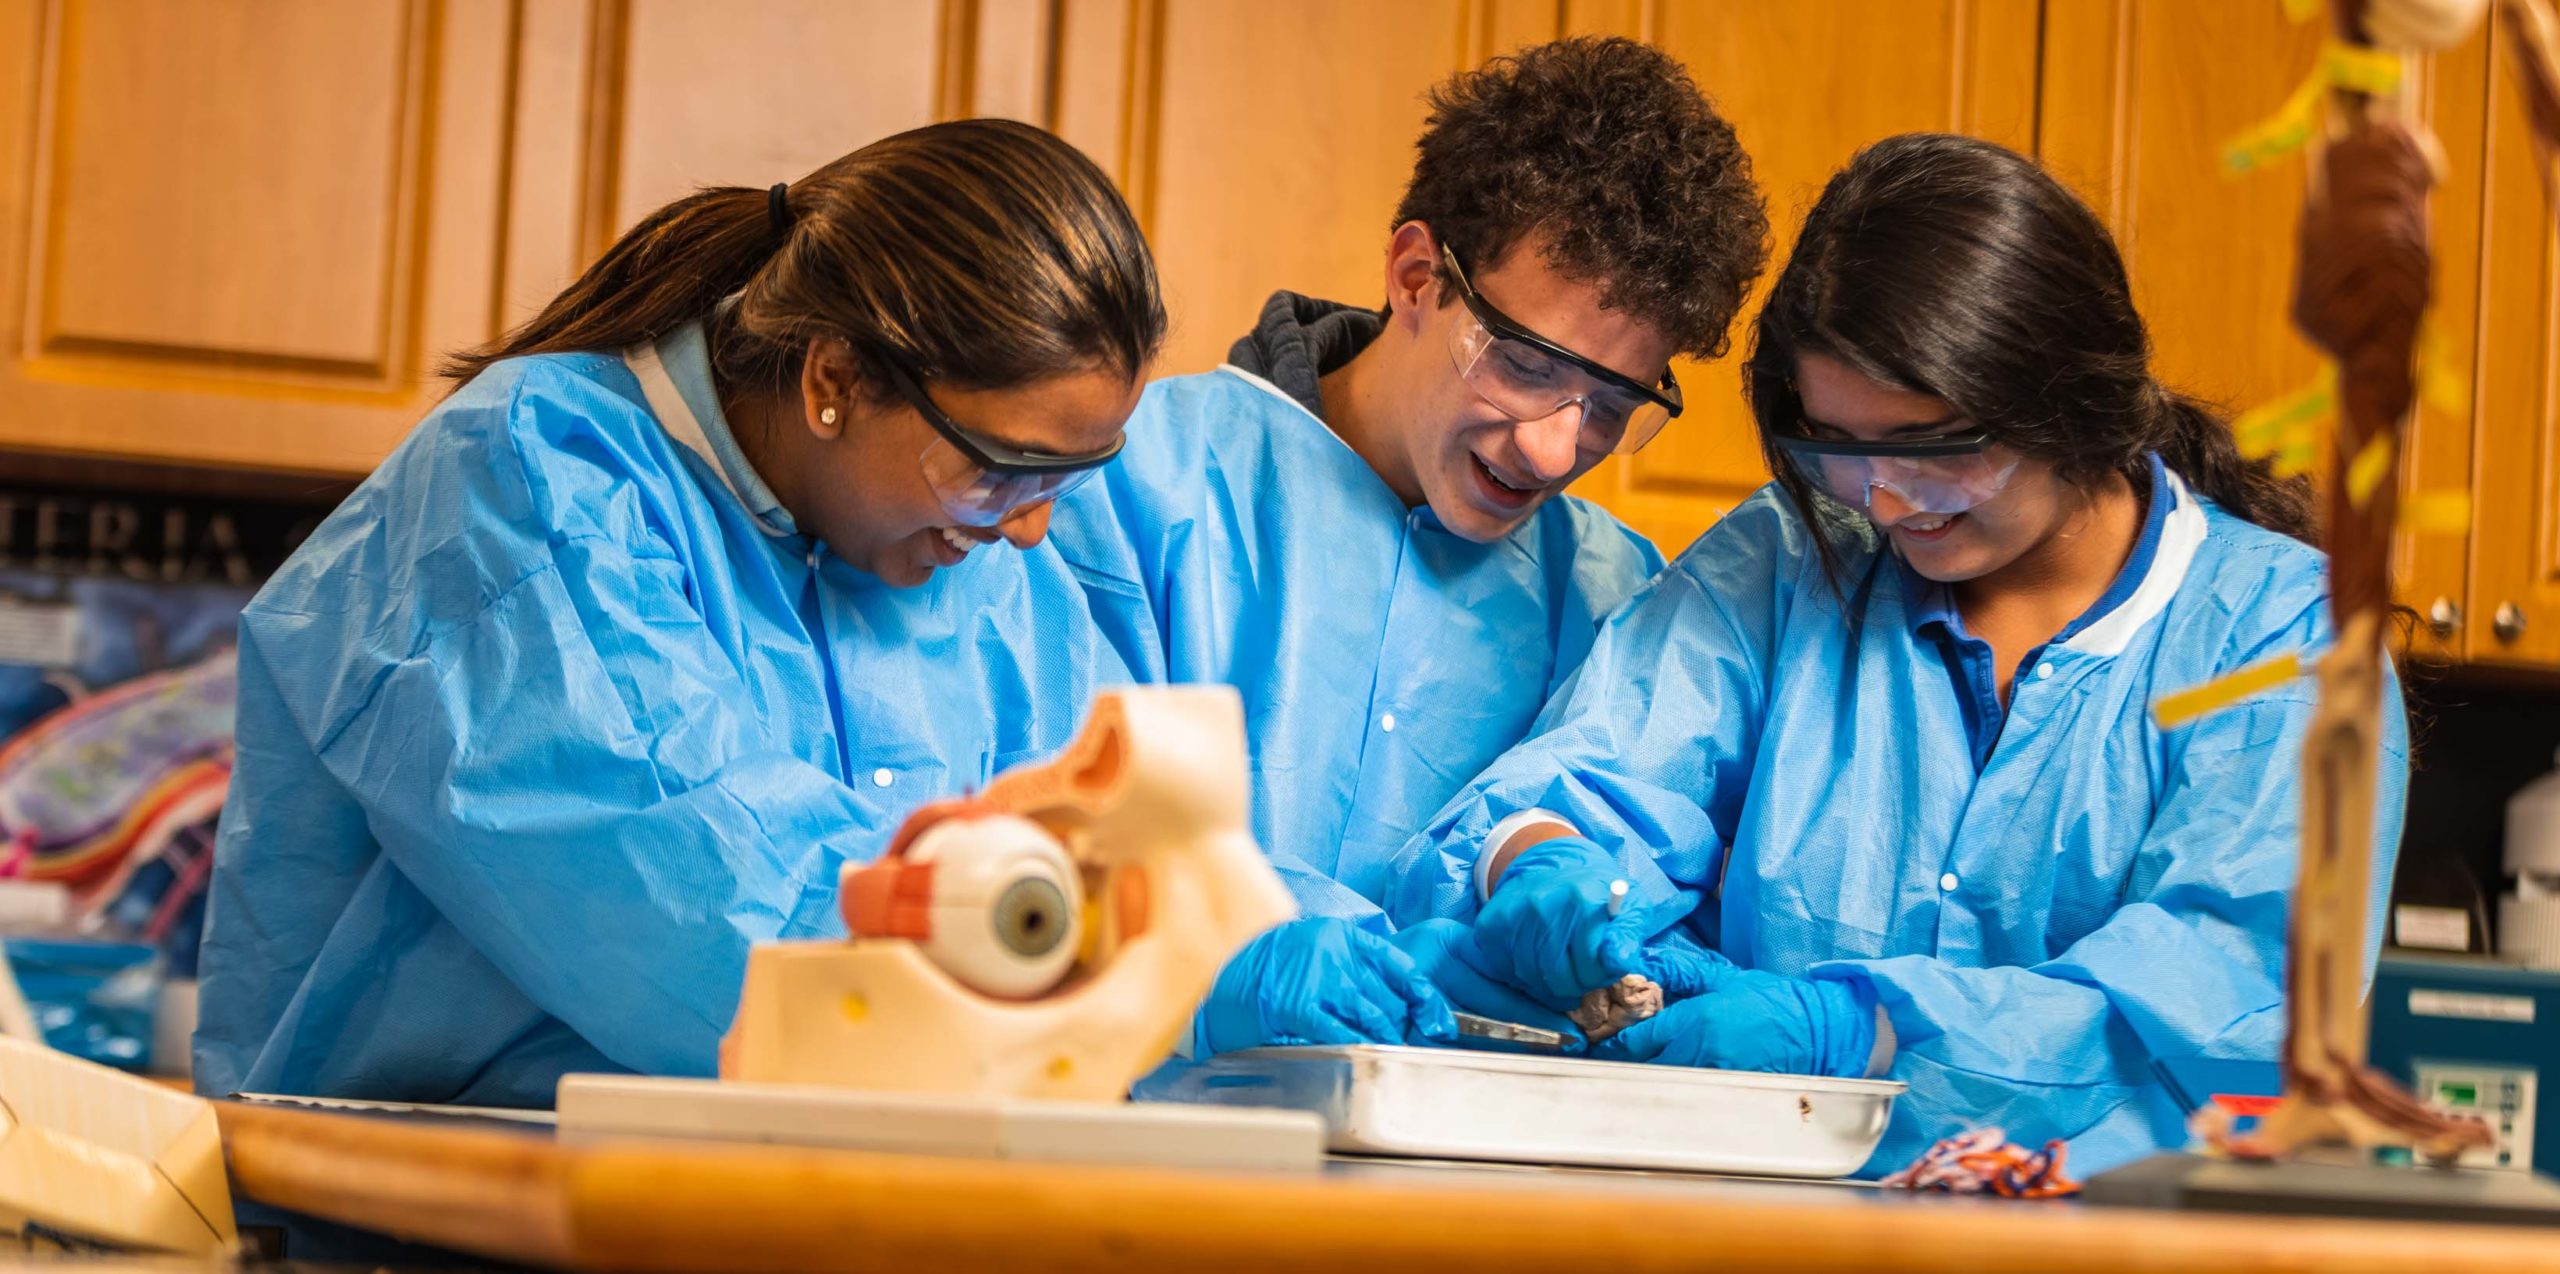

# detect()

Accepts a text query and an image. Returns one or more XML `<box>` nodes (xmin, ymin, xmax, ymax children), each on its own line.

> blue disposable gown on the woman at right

<box><xmin>1395</xmin><ymin>476</ymin><xmax>2406</xmax><ymax>1172</ymax></box>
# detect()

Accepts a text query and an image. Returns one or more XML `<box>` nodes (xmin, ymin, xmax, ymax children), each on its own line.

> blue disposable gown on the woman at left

<box><xmin>195</xmin><ymin>325</ymin><xmax>1126</xmax><ymax>1105</ymax></box>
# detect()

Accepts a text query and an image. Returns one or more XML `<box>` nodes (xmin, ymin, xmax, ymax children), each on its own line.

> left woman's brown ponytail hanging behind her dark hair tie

<box><xmin>440</xmin><ymin>187</ymin><xmax>783</xmax><ymax>381</ymax></box>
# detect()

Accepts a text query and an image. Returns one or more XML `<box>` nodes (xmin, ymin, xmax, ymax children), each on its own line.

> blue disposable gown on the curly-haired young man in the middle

<box><xmin>1050</xmin><ymin>366</ymin><xmax>1661</xmax><ymax>929</ymax></box>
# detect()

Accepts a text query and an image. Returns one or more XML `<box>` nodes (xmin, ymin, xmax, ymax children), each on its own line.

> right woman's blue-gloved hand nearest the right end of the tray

<box><xmin>1592</xmin><ymin>964</ymin><xmax>1876</xmax><ymax>1080</ymax></box>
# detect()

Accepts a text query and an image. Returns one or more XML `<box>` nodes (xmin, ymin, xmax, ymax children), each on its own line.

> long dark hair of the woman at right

<box><xmin>1743</xmin><ymin>133</ymin><xmax>2312</xmax><ymax>578</ymax></box>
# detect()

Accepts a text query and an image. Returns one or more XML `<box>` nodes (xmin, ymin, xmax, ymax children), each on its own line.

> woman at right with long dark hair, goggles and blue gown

<box><xmin>1395</xmin><ymin>136</ymin><xmax>2406</xmax><ymax>1172</ymax></box>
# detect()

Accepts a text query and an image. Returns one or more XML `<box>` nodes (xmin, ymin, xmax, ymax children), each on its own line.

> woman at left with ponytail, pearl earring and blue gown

<box><xmin>209</xmin><ymin>120</ymin><xmax>1165</xmax><ymax>1105</ymax></box>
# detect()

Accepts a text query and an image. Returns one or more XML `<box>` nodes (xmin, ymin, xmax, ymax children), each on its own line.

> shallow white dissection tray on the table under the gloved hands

<box><xmin>1134</xmin><ymin>1044</ymin><xmax>1902</xmax><ymax>1177</ymax></box>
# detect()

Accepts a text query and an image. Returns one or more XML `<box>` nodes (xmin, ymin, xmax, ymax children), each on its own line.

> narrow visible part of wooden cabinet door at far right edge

<box><xmin>2463</xmin><ymin>7</ymin><xmax>2560</xmax><ymax>668</ymax></box>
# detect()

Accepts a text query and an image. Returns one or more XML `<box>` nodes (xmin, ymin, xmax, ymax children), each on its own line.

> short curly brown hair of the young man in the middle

<box><xmin>1395</xmin><ymin>36</ymin><xmax>1769</xmax><ymax>358</ymax></box>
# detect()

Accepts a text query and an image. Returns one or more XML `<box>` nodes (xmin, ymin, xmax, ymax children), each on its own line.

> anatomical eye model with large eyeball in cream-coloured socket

<box><xmin>719</xmin><ymin>686</ymin><xmax>1298</xmax><ymax>1103</ymax></box>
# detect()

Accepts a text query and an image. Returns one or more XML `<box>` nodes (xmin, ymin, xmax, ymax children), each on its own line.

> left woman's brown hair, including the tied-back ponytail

<box><xmin>443</xmin><ymin>120</ymin><xmax>1165</xmax><ymax>397</ymax></box>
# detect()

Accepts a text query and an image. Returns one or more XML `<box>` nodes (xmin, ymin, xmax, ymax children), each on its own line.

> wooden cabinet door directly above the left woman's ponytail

<box><xmin>440</xmin><ymin>0</ymin><xmax>1018</xmax><ymax>383</ymax></box>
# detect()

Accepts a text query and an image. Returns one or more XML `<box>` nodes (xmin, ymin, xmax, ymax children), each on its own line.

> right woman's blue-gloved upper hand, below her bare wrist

<box><xmin>1475</xmin><ymin>837</ymin><xmax>1697</xmax><ymax>1013</ymax></box>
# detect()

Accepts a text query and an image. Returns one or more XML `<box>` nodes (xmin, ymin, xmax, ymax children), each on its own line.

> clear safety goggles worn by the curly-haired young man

<box><xmin>1441</xmin><ymin>243</ymin><xmax>1679</xmax><ymax>455</ymax></box>
